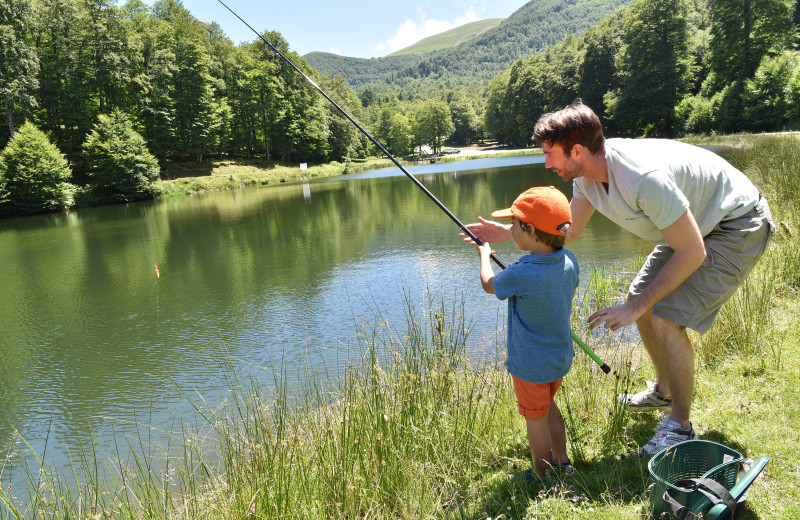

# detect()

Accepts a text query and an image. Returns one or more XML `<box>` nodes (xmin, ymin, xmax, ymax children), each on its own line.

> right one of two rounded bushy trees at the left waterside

<box><xmin>83</xmin><ymin>110</ymin><xmax>159</xmax><ymax>202</ymax></box>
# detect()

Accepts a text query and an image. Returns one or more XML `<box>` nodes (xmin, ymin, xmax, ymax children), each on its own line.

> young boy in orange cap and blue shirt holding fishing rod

<box><xmin>477</xmin><ymin>186</ymin><xmax>578</xmax><ymax>480</ymax></box>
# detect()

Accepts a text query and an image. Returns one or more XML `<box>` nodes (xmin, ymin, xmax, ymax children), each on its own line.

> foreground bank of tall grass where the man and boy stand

<box><xmin>0</xmin><ymin>136</ymin><xmax>800</xmax><ymax>520</ymax></box>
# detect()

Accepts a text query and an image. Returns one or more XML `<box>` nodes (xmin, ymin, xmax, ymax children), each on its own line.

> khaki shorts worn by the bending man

<box><xmin>628</xmin><ymin>198</ymin><xmax>775</xmax><ymax>334</ymax></box>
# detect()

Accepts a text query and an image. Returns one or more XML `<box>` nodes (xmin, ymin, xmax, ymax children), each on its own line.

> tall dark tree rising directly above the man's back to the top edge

<box><xmin>605</xmin><ymin>0</ymin><xmax>693</xmax><ymax>135</ymax></box>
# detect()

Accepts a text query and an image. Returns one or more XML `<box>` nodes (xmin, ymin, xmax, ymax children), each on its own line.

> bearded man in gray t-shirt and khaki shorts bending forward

<box><xmin>465</xmin><ymin>101</ymin><xmax>775</xmax><ymax>455</ymax></box>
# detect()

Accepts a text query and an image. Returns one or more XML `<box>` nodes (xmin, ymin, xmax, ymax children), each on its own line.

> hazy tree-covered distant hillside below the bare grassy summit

<box><xmin>305</xmin><ymin>0</ymin><xmax>633</xmax><ymax>92</ymax></box>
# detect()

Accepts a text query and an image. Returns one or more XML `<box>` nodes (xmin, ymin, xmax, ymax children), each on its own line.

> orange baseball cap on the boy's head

<box><xmin>492</xmin><ymin>186</ymin><xmax>572</xmax><ymax>235</ymax></box>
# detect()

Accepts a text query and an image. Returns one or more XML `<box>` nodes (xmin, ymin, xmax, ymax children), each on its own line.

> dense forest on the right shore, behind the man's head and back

<box><xmin>483</xmin><ymin>0</ymin><xmax>800</xmax><ymax>145</ymax></box>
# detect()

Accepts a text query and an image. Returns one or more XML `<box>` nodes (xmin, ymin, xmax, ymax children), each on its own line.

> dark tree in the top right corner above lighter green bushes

<box><xmin>709</xmin><ymin>0</ymin><xmax>795</xmax><ymax>85</ymax></box>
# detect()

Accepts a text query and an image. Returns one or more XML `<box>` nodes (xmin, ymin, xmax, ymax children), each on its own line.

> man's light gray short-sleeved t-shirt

<box><xmin>573</xmin><ymin>139</ymin><xmax>759</xmax><ymax>244</ymax></box>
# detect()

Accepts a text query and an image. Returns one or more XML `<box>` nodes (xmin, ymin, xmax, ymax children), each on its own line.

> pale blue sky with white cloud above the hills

<box><xmin>183</xmin><ymin>0</ymin><xmax>528</xmax><ymax>58</ymax></box>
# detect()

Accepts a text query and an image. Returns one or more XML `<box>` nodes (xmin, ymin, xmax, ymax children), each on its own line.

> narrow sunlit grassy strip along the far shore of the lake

<box><xmin>158</xmin><ymin>148</ymin><xmax>538</xmax><ymax>197</ymax></box>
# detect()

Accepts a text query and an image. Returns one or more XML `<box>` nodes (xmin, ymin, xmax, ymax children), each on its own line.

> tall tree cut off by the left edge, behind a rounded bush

<box><xmin>0</xmin><ymin>0</ymin><xmax>39</xmax><ymax>145</ymax></box>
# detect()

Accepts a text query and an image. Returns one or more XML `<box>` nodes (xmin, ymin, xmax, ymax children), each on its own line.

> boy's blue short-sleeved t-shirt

<box><xmin>494</xmin><ymin>248</ymin><xmax>579</xmax><ymax>383</ymax></box>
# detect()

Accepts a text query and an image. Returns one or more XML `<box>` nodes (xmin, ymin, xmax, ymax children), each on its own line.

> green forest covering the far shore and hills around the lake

<box><xmin>0</xmin><ymin>0</ymin><xmax>800</xmax><ymax>216</ymax></box>
